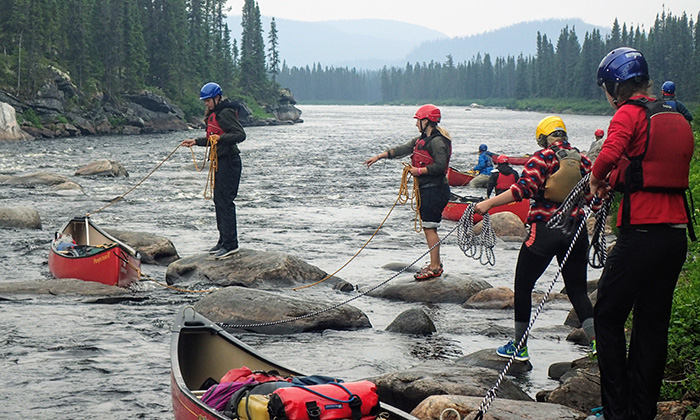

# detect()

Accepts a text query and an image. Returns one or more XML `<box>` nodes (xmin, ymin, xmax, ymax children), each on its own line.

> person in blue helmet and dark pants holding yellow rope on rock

<box><xmin>180</xmin><ymin>83</ymin><xmax>246</xmax><ymax>259</ymax></box>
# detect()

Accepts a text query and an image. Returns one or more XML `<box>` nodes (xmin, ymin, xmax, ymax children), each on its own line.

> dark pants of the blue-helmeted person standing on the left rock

<box><xmin>214</xmin><ymin>153</ymin><xmax>242</xmax><ymax>251</ymax></box>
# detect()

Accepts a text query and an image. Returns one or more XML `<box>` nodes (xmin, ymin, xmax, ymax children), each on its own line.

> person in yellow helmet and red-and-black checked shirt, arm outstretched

<box><xmin>474</xmin><ymin>116</ymin><xmax>595</xmax><ymax>362</ymax></box>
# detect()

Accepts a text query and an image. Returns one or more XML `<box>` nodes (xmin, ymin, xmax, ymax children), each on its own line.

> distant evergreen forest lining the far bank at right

<box><xmin>278</xmin><ymin>13</ymin><xmax>700</xmax><ymax>104</ymax></box>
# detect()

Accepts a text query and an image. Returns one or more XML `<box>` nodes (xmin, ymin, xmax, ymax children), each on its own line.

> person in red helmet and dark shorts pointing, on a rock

<box><xmin>364</xmin><ymin>104</ymin><xmax>452</xmax><ymax>281</ymax></box>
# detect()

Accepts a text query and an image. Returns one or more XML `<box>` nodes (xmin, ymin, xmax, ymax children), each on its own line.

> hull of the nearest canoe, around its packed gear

<box><xmin>170</xmin><ymin>307</ymin><xmax>418</xmax><ymax>420</ymax></box>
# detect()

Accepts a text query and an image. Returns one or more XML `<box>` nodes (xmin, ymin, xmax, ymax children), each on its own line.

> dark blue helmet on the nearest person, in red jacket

<box><xmin>598</xmin><ymin>47</ymin><xmax>649</xmax><ymax>96</ymax></box>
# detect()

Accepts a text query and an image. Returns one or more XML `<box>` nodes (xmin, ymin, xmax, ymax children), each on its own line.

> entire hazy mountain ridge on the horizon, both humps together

<box><xmin>226</xmin><ymin>16</ymin><xmax>610</xmax><ymax>70</ymax></box>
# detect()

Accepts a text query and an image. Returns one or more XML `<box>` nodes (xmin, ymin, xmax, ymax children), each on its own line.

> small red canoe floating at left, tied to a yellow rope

<box><xmin>49</xmin><ymin>217</ymin><xmax>141</xmax><ymax>287</ymax></box>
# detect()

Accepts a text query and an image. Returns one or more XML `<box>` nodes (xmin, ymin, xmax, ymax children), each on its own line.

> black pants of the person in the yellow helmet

<box><xmin>515</xmin><ymin>222</ymin><xmax>593</xmax><ymax>323</ymax></box>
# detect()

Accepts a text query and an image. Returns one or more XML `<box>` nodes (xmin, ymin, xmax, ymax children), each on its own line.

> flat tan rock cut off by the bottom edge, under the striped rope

<box><xmin>411</xmin><ymin>393</ymin><xmax>586</xmax><ymax>420</ymax></box>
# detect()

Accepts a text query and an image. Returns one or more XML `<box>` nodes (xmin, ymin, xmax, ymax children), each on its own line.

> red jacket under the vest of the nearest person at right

<box><xmin>593</xmin><ymin>96</ymin><xmax>688</xmax><ymax>226</ymax></box>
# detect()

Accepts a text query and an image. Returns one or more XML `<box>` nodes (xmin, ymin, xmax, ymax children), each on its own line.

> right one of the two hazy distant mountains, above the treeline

<box><xmin>404</xmin><ymin>19</ymin><xmax>610</xmax><ymax>63</ymax></box>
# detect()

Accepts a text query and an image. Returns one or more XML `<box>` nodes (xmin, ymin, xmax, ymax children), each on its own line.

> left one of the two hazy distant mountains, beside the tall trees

<box><xmin>226</xmin><ymin>16</ymin><xmax>448</xmax><ymax>69</ymax></box>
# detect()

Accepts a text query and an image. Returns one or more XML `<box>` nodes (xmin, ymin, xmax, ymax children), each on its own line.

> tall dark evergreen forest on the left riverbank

<box><xmin>0</xmin><ymin>0</ymin><xmax>279</xmax><ymax>118</ymax></box>
